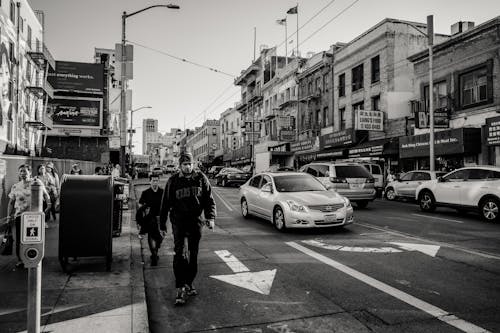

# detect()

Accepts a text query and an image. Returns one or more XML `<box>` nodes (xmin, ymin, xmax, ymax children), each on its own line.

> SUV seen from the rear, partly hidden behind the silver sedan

<box><xmin>300</xmin><ymin>162</ymin><xmax>376</xmax><ymax>208</ymax></box>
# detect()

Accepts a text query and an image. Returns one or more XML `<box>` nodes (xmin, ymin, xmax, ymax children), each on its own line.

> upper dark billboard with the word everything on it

<box><xmin>47</xmin><ymin>61</ymin><xmax>104</xmax><ymax>94</ymax></box>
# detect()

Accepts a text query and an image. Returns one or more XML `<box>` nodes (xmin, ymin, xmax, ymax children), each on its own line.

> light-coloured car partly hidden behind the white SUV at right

<box><xmin>385</xmin><ymin>170</ymin><xmax>446</xmax><ymax>201</ymax></box>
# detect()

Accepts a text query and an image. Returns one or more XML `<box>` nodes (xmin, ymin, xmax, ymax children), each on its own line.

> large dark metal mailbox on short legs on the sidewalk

<box><xmin>59</xmin><ymin>175</ymin><xmax>114</xmax><ymax>272</ymax></box>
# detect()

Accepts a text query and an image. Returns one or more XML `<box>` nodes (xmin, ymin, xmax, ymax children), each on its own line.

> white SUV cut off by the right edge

<box><xmin>415</xmin><ymin>166</ymin><xmax>500</xmax><ymax>222</ymax></box>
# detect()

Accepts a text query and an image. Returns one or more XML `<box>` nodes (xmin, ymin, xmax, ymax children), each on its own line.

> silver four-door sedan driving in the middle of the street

<box><xmin>240</xmin><ymin>172</ymin><xmax>354</xmax><ymax>231</ymax></box>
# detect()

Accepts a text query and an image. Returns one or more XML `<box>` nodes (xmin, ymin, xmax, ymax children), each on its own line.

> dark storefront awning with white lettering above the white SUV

<box><xmin>399</xmin><ymin>128</ymin><xmax>481</xmax><ymax>158</ymax></box>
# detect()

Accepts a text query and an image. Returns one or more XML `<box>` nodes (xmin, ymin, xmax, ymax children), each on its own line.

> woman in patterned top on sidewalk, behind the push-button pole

<box><xmin>7</xmin><ymin>164</ymin><xmax>51</xmax><ymax>268</ymax></box>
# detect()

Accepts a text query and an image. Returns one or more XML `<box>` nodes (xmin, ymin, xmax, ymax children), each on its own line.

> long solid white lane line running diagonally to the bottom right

<box><xmin>285</xmin><ymin>242</ymin><xmax>489</xmax><ymax>333</ymax></box>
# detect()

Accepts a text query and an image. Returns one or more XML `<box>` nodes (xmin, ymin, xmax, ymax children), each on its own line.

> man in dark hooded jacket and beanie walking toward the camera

<box><xmin>160</xmin><ymin>152</ymin><xmax>216</xmax><ymax>305</ymax></box>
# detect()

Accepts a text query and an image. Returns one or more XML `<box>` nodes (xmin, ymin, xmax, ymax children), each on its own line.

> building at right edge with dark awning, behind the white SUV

<box><xmin>406</xmin><ymin>16</ymin><xmax>500</xmax><ymax>170</ymax></box>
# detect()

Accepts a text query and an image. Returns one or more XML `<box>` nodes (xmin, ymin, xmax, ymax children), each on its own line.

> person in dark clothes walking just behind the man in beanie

<box><xmin>136</xmin><ymin>175</ymin><xmax>163</xmax><ymax>266</ymax></box>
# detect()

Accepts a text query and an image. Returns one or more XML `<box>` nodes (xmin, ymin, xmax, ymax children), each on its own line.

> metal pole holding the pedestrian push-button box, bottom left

<box><xmin>26</xmin><ymin>179</ymin><xmax>45</xmax><ymax>333</ymax></box>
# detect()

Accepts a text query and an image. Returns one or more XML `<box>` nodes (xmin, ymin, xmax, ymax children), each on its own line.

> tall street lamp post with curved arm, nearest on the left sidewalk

<box><xmin>120</xmin><ymin>4</ymin><xmax>180</xmax><ymax>176</ymax></box>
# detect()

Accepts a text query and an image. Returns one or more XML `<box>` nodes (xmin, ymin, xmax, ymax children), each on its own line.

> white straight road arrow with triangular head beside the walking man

<box><xmin>210</xmin><ymin>250</ymin><xmax>276</xmax><ymax>295</ymax></box>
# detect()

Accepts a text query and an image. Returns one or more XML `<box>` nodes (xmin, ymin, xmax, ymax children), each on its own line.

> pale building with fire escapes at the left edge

<box><xmin>0</xmin><ymin>0</ymin><xmax>55</xmax><ymax>156</ymax></box>
